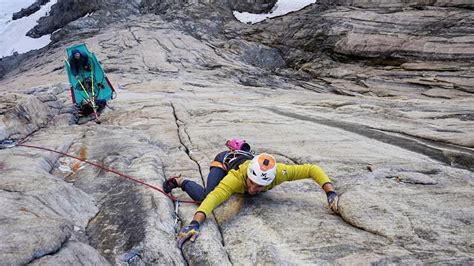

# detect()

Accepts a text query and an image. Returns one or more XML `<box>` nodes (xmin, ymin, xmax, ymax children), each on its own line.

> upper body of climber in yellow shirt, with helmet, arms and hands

<box><xmin>178</xmin><ymin>153</ymin><xmax>338</xmax><ymax>248</ymax></box>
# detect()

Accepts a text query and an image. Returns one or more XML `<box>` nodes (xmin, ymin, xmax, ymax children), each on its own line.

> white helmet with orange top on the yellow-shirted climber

<box><xmin>247</xmin><ymin>153</ymin><xmax>276</xmax><ymax>186</ymax></box>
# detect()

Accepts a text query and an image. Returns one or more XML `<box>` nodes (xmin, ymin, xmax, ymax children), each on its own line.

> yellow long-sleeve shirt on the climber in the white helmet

<box><xmin>197</xmin><ymin>161</ymin><xmax>331</xmax><ymax>217</ymax></box>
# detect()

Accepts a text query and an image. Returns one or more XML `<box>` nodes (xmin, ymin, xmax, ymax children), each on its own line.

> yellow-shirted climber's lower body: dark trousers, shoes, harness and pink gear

<box><xmin>163</xmin><ymin>138</ymin><xmax>253</xmax><ymax>201</ymax></box>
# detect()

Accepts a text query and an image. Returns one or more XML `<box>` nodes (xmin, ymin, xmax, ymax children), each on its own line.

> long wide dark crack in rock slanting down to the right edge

<box><xmin>266</xmin><ymin>108</ymin><xmax>474</xmax><ymax>171</ymax></box>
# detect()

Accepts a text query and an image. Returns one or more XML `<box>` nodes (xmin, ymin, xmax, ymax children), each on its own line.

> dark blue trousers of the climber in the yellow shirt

<box><xmin>181</xmin><ymin>167</ymin><xmax>227</xmax><ymax>201</ymax></box>
